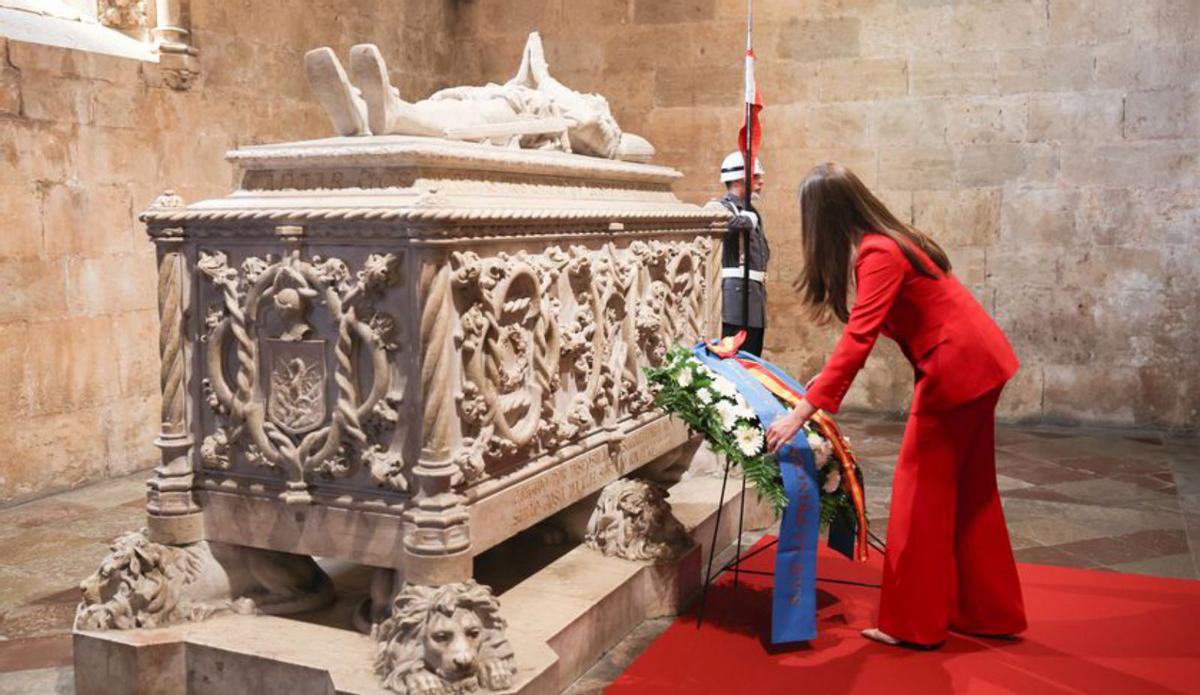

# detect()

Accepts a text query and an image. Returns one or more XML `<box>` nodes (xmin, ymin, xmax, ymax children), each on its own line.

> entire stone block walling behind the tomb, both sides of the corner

<box><xmin>0</xmin><ymin>0</ymin><xmax>1200</xmax><ymax>505</ymax></box>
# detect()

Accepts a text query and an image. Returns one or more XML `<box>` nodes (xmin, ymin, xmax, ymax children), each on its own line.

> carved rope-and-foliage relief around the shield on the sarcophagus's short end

<box><xmin>197</xmin><ymin>250</ymin><xmax>408</xmax><ymax>503</ymax></box>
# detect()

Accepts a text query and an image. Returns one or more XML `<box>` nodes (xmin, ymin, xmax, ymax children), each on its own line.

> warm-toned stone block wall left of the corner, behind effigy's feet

<box><xmin>0</xmin><ymin>0</ymin><xmax>455</xmax><ymax>505</ymax></box>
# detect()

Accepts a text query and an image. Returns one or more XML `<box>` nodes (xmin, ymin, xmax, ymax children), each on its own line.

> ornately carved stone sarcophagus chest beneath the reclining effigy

<box><xmin>143</xmin><ymin>136</ymin><xmax>726</xmax><ymax>586</ymax></box>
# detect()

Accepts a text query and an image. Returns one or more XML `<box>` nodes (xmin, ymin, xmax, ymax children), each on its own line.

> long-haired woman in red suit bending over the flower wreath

<box><xmin>767</xmin><ymin>164</ymin><xmax>1026</xmax><ymax>647</ymax></box>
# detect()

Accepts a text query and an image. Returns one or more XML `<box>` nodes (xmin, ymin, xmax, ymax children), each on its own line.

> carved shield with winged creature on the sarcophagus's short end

<box><xmin>266</xmin><ymin>340</ymin><xmax>326</xmax><ymax>435</ymax></box>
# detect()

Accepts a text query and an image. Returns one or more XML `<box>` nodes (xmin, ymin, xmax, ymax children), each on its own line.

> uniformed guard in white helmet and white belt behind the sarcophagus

<box><xmin>720</xmin><ymin>151</ymin><xmax>770</xmax><ymax>355</ymax></box>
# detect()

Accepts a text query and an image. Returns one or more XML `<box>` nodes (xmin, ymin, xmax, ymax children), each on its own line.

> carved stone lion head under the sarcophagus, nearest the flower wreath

<box><xmin>583</xmin><ymin>479</ymin><xmax>691</xmax><ymax>562</ymax></box>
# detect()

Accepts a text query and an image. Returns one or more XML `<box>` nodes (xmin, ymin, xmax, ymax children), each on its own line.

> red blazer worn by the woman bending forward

<box><xmin>804</xmin><ymin>234</ymin><xmax>1019</xmax><ymax>413</ymax></box>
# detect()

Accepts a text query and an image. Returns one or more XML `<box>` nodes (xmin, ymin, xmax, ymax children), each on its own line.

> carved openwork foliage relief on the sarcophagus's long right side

<box><xmin>448</xmin><ymin>238</ymin><xmax>712</xmax><ymax>484</ymax></box>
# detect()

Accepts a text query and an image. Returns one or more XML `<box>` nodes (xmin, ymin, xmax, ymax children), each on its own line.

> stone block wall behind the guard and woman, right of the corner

<box><xmin>454</xmin><ymin>0</ymin><xmax>1200</xmax><ymax>430</ymax></box>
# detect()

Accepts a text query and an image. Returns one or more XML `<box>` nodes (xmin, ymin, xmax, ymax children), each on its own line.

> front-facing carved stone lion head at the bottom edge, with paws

<box><xmin>372</xmin><ymin>580</ymin><xmax>516</xmax><ymax>695</ymax></box>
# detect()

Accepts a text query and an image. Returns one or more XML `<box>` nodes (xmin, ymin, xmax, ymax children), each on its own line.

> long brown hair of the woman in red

<box><xmin>794</xmin><ymin>162</ymin><xmax>950</xmax><ymax>323</ymax></box>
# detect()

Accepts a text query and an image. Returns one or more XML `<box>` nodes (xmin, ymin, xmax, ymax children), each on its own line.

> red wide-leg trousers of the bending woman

<box><xmin>878</xmin><ymin>389</ymin><xmax>1026</xmax><ymax>645</ymax></box>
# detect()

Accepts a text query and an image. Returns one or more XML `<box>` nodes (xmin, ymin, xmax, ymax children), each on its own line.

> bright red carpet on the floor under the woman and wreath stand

<box><xmin>606</xmin><ymin>535</ymin><xmax>1200</xmax><ymax>695</ymax></box>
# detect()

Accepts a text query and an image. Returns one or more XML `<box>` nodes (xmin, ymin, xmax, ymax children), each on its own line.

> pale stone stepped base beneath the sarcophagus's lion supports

<box><xmin>74</xmin><ymin>478</ymin><xmax>772</xmax><ymax>695</ymax></box>
